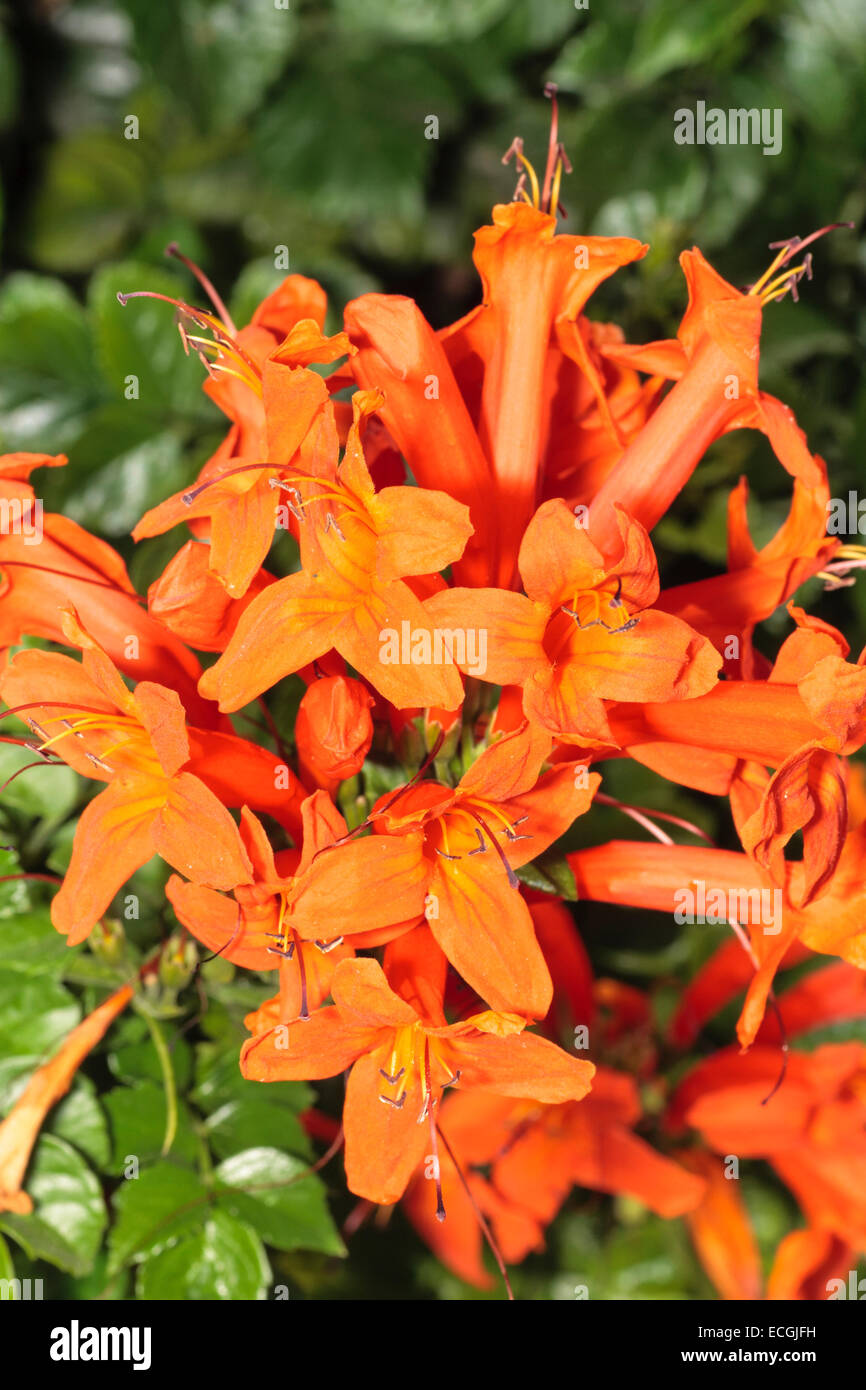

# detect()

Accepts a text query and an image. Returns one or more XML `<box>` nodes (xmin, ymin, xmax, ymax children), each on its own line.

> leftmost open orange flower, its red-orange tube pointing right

<box><xmin>0</xmin><ymin>612</ymin><xmax>315</xmax><ymax>945</ymax></box>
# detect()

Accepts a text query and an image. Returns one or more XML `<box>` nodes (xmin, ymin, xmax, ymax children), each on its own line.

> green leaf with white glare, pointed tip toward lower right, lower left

<box><xmin>214</xmin><ymin>1148</ymin><xmax>346</xmax><ymax>1255</ymax></box>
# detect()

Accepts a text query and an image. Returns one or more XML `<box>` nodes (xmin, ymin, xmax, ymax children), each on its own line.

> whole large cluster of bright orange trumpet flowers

<box><xmin>0</xmin><ymin>111</ymin><xmax>866</xmax><ymax>1297</ymax></box>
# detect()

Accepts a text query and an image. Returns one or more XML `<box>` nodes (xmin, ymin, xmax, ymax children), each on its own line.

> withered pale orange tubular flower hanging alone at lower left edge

<box><xmin>0</xmin><ymin>984</ymin><xmax>132</xmax><ymax>1216</ymax></box>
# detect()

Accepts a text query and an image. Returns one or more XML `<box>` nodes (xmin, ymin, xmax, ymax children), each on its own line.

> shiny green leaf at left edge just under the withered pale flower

<box><xmin>0</xmin><ymin>1134</ymin><xmax>107</xmax><ymax>1276</ymax></box>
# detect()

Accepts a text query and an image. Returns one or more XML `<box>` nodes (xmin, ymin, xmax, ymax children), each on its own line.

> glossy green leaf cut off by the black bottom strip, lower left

<box><xmin>136</xmin><ymin>1212</ymin><xmax>271</xmax><ymax>1302</ymax></box>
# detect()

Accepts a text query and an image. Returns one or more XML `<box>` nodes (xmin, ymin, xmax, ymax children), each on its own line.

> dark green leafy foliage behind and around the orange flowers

<box><xmin>0</xmin><ymin>0</ymin><xmax>866</xmax><ymax>1300</ymax></box>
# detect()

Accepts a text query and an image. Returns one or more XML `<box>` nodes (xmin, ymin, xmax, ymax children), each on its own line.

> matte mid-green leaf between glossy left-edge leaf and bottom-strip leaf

<box><xmin>108</xmin><ymin>1162</ymin><xmax>207</xmax><ymax>1272</ymax></box>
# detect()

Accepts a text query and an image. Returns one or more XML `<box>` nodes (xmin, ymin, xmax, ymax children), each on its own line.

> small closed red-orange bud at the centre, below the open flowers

<box><xmin>295</xmin><ymin>676</ymin><xmax>374</xmax><ymax>792</ymax></box>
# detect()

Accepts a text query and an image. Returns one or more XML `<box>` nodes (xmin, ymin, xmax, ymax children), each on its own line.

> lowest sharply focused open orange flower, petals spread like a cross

<box><xmin>240</xmin><ymin>929</ymin><xmax>594</xmax><ymax>1204</ymax></box>
